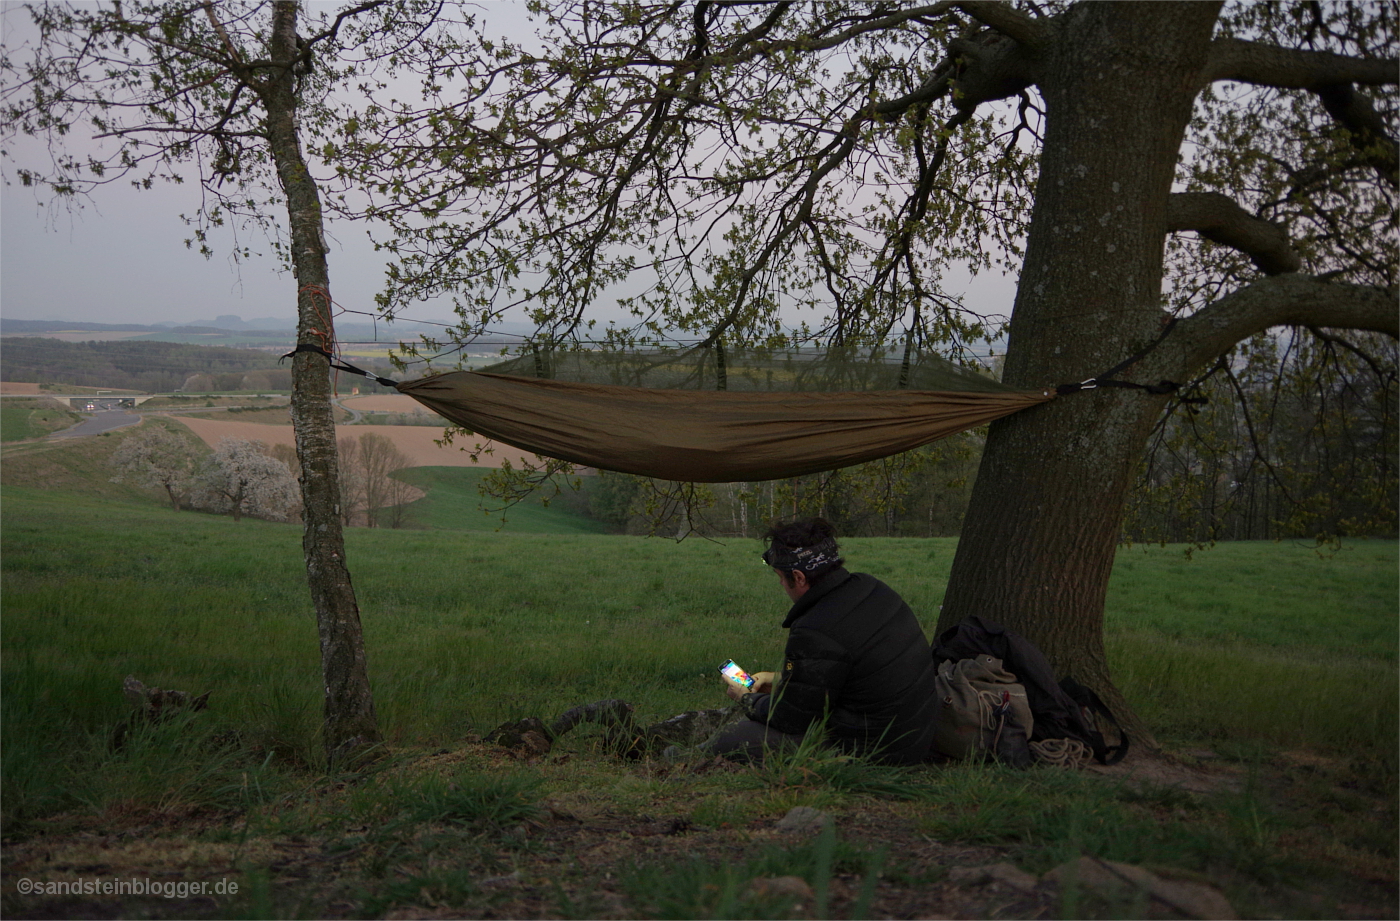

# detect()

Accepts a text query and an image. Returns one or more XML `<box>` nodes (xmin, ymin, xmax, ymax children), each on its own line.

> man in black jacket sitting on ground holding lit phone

<box><xmin>704</xmin><ymin>518</ymin><xmax>938</xmax><ymax>764</ymax></box>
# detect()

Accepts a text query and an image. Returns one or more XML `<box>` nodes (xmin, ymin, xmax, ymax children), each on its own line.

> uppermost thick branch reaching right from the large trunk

<box><xmin>1201</xmin><ymin>38</ymin><xmax>1400</xmax><ymax>90</ymax></box>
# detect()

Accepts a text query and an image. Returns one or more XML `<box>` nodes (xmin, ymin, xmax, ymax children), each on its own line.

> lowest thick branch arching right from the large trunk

<box><xmin>1172</xmin><ymin>274</ymin><xmax>1400</xmax><ymax>371</ymax></box>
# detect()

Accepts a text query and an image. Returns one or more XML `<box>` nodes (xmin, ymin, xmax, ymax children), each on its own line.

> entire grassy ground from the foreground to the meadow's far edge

<box><xmin>0</xmin><ymin>475</ymin><xmax>1400</xmax><ymax>917</ymax></box>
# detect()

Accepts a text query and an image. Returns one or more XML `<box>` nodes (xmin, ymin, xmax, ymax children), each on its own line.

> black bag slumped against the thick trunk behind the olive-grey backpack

<box><xmin>934</xmin><ymin>616</ymin><xmax>1128</xmax><ymax>764</ymax></box>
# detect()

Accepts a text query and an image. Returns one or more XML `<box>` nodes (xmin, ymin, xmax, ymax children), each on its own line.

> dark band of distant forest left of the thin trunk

<box><xmin>0</xmin><ymin>337</ymin><xmax>392</xmax><ymax>393</ymax></box>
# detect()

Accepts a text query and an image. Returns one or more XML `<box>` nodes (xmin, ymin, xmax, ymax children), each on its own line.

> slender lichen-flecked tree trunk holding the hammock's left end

<box><xmin>265</xmin><ymin>0</ymin><xmax>379</xmax><ymax>763</ymax></box>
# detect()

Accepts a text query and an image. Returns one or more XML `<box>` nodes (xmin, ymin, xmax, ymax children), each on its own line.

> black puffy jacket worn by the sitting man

<box><xmin>743</xmin><ymin>568</ymin><xmax>938</xmax><ymax>763</ymax></box>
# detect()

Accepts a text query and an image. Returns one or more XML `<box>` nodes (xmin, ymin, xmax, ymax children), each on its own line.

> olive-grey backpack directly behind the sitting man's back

<box><xmin>934</xmin><ymin>655</ymin><xmax>1035</xmax><ymax>767</ymax></box>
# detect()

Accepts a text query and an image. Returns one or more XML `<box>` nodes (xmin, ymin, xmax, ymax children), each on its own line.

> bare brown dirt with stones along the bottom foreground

<box><xmin>0</xmin><ymin>745</ymin><xmax>1397</xmax><ymax>918</ymax></box>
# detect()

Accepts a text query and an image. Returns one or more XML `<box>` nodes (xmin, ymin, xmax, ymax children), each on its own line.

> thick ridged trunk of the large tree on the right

<box><xmin>939</xmin><ymin>3</ymin><xmax>1219</xmax><ymax>746</ymax></box>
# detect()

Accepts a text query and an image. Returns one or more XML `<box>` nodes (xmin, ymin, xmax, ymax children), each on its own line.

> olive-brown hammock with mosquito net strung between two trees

<box><xmin>382</xmin><ymin>349</ymin><xmax>1056</xmax><ymax>483</ymax></box>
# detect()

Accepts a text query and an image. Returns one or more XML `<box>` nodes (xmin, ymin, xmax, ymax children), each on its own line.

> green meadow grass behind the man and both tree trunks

<box><xmin>3</xmin><ymin>488</ymin><xmax>1396</xmax><ymax>746</ymax></box>
